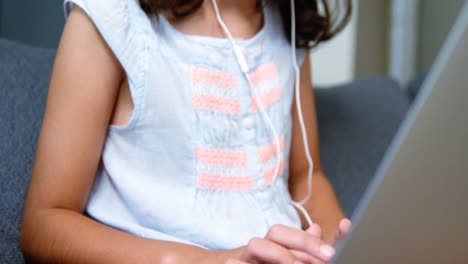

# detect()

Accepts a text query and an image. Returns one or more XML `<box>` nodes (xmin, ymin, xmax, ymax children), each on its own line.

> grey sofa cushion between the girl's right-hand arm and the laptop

<box><xmin>315</xmin><ymin>77</ymin><xmax>410</xmax><ymax>216</ymax></box>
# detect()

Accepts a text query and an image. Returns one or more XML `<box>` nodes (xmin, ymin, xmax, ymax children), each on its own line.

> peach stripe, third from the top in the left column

<box><xmin>197</xmin><ymin>147</ymin><xmax>247</xmax><ymax>167</ymax></box>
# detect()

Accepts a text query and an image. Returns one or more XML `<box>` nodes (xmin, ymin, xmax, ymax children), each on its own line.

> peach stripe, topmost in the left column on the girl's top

<box><xmin>190</xmin><ymin>67</ymin><xmax>239</xmax><ymax>89</ymax></box>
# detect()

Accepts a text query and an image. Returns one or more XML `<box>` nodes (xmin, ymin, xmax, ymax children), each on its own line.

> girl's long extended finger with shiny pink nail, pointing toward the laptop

<box><xmin>266</xmin><ymin>225</ymin><xmax>335</xmax><ymax>262</ymax></box>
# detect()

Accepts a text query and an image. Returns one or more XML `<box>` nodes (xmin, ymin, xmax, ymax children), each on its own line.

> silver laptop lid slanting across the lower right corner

<box><xmin>332</xmin><ymin>1</ymin><xmax>468</xmax><ymax>264</ymax></box>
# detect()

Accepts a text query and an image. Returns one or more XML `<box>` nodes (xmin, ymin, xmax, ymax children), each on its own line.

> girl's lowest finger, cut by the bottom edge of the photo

<box><xmin>241</xmin><ymin>238</ymin><xmax>296</xmax><ymax>263</ymax></box>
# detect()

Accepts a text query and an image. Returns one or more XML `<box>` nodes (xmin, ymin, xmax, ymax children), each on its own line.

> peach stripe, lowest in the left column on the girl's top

<box><xmin>197</xmin><ymin>172</ymin><xmax>253</xmax><ymax>191</ymax></box>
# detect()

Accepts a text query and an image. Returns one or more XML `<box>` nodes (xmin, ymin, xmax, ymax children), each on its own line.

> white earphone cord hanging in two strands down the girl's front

<box><xmin>212</xmin><ymin>0</ymin><xmax>313</xmax><ymax>226</ymax></box>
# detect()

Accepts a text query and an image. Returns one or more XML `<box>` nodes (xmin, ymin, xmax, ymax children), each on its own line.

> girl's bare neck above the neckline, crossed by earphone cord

<box><xmin>164</xmin><ymin>0</ymin><xmax>263</xmax><ymax>39</ymax></box>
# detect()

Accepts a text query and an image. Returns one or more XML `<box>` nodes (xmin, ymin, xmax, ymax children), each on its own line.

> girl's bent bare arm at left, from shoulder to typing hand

<box><xmin>20</xmin><ymin>7</ymin><xmax>331</xmax><ymax>264</ymax></box>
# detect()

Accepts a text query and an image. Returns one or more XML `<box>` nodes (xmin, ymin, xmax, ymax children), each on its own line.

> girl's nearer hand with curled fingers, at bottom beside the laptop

<box><xmin>226</xmin><ymin>224</ymin><xmax>335</xmax><ymax>264</ymax></box>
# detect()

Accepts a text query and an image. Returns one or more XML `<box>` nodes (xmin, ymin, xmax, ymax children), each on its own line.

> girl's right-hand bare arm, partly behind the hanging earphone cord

<box><xmin>289</xmin><ymin>55</ymin><xmax>350</xmax><ymax>242</ymax></box>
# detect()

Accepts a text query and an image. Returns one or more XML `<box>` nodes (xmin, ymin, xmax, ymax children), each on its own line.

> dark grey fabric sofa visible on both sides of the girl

<box><xmin>0</xmin><ymin>39</ymin><xmax>410</xmax><ymax>263</ymax></box>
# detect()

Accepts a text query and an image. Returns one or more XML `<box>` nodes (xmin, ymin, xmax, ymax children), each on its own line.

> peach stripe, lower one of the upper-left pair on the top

<box><xmin>192</xmin><ymin>95</ymin><xmax>240</xmax><ymax>114</ymax></box>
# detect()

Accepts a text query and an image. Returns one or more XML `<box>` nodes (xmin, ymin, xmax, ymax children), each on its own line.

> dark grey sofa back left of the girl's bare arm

<box><xmin>0</xmin><ymin>39</ymin><xmax>54</xmax><ymax>263</ymax></box>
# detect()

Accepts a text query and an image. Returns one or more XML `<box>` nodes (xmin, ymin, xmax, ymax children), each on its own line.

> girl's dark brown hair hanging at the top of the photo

<box><xmin>139</xmin><ymin>0</ymin><xmax>352</xmax><ymax>48</ymax></box>
